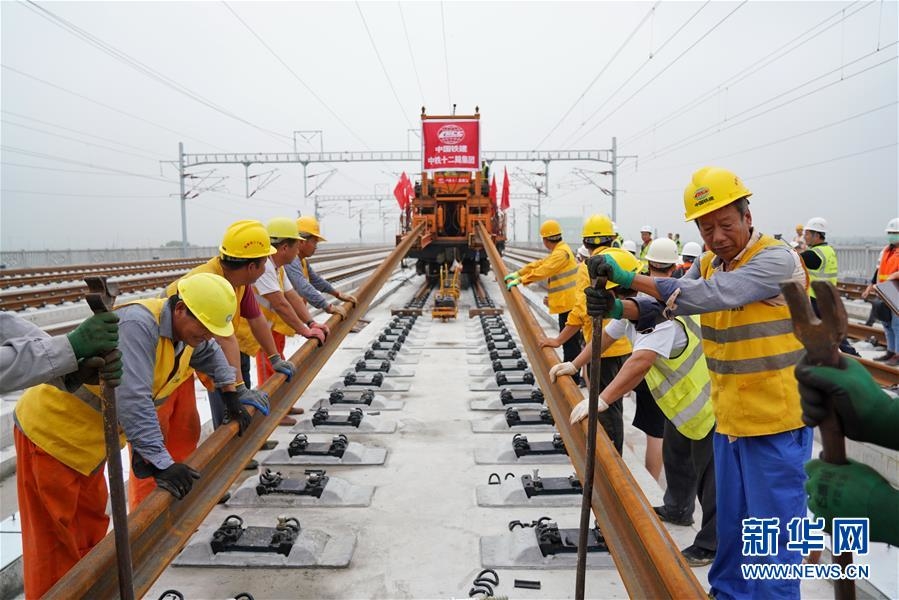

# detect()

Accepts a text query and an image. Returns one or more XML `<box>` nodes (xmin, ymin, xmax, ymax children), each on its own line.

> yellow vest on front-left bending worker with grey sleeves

<box><xmin>15</xmin><ymin>298</ymin><xmax>194</xmax><ymax>475</ymax></box>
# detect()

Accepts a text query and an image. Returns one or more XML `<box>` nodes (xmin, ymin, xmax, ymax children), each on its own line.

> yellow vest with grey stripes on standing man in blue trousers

<box><xmin>700</xmin><ymin>235</ymin><xmax>803</xmax><ymax>437</ymax></box>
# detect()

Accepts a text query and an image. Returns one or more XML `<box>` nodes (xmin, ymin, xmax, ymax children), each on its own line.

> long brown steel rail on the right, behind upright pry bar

<box><xmin>478</xmin><ymin>225</ymin><xmax>708</xmax><ymax>599</ymax></box>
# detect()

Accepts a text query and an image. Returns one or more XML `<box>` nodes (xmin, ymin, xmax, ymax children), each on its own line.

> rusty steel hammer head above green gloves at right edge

<box><xmin>780</xmin><ymin>281</ymin><xmax>849</xmax><ymax>366</ymax></box>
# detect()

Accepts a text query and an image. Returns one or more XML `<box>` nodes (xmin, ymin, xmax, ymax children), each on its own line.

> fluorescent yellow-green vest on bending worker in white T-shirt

<box><xmin>646</xmin><ymin>316</ymin><xmax>715</xmax><ymax>440</ymax></box>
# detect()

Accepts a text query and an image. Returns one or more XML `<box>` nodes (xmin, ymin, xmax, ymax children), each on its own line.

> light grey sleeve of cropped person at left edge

<box><xmin>0</xmin><ymin>311</ymin><xmax>78</xmax><ymax>393</ymax></box>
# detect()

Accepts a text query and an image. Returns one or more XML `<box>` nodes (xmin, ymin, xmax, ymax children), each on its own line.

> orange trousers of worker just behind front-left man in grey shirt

<box><xmin>128</xmin><ymin>377</ymin><xmax>200</xmax><ymax>511</ymax></box>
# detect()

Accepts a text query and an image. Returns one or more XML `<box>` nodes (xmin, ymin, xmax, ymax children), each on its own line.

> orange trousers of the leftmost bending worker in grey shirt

<box><xmin>13</xmin><ymin>427</ymin><xmax>109</xmax><ymax>599</ymax></box>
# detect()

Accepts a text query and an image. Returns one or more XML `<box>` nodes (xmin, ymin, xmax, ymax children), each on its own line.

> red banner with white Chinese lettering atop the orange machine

<box><xmin>421</xmin><ymin>119</ymin><xmax>481</xmax><ymax>171</ymax></box>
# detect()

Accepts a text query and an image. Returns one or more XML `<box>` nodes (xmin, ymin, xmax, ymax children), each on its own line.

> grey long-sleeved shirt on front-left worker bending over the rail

<box><xmin>116</xmin><ymin>303</ymin><xmax>235</xmax><ymax>469</ymax></box>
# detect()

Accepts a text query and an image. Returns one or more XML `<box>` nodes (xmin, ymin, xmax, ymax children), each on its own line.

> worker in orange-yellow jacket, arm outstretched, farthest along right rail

<box><xmin>505</xmin><ymin>219</ymin><xmax>581</xmax><ymax>383</ymax></box>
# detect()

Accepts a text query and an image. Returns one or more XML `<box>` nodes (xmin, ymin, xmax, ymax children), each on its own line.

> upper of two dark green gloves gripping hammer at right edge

<box><xmin>796</xmin><ymin>356</ymin><xmax>899</xmax><ymax>449</ymax></box>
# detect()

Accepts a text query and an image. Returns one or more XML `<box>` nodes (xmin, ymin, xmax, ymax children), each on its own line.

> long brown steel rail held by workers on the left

<box><xmin>44</xmin><ymin>225</ymin><xmax>424</xmax><ymax>600</ymax></box>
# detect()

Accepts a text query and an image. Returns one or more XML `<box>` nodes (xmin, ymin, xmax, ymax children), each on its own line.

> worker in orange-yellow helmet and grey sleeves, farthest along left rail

<box><xmin>284</xmin><ymin>216</ymin><xmax>356</xmax><ymax>319</ymax></box>
